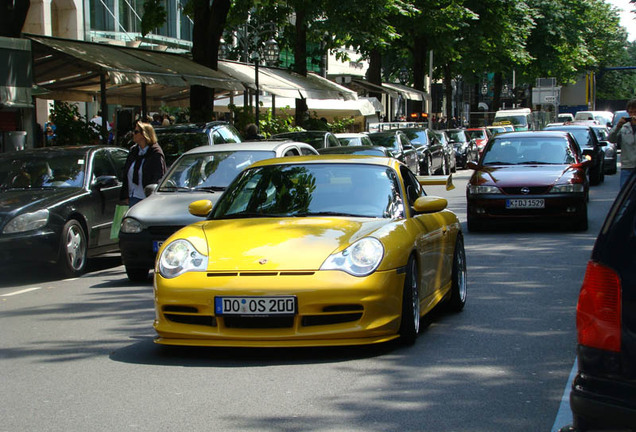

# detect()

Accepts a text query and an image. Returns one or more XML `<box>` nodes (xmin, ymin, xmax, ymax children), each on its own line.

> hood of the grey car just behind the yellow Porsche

<box><xmin>126</xmin><ymin>192</ymin><xmax>222</xmax><ymax>226</ymax></box>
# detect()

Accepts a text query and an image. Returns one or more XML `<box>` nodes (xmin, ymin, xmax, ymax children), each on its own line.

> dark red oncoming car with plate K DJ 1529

<box><xmin>466</xmin><ymin>131</ymin><xmax>589</xmax><ymax>231</ymax></box>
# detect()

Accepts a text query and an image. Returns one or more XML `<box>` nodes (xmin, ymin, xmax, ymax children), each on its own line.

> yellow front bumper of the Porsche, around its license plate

<box><xmin>154</xmin><ymin>270</ymin><xmax>404</xmax><ymax>347</ymax></box>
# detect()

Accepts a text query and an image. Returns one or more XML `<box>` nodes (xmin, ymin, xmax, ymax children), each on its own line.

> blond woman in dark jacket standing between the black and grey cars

<box><xmin>120</xmin><ymin>122</ymin><xmax>166</xmax><ymax>207</ymax></box>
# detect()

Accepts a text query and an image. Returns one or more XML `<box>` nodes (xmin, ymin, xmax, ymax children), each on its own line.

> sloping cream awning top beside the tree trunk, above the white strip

<box><xmin>219</xmin><ymin>60</ymin><xmax>358</xmax><ymax>100</ymax></box>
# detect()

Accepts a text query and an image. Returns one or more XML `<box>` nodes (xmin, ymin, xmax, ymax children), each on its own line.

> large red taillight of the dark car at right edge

<box><xmin>576</xmin><ymin>261</ymin><xmax>621</xmax><ymax>352</ymax></box>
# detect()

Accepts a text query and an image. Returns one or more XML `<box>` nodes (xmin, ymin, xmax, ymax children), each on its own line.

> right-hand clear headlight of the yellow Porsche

<box><xmin>320</xmin><ymin>237</ymin><xmax>384</xmax><ymax>276</ymax></box>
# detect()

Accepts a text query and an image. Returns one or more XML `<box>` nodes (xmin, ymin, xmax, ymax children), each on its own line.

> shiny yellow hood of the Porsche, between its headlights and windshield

<box><xmin>202</xmin><ymin>217</ymin><xmax>390</xmax><ymax>271</ymax></box>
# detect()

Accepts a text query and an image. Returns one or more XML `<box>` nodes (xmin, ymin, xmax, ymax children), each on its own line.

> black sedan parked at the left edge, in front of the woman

<box><xmin>0</xmin><ymin>146</ymin><xmax>128</xmax><ymax>277</ymax></box>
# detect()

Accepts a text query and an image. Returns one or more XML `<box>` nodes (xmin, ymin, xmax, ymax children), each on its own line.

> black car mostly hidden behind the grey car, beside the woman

<box><xmin>155</xmin><ymin>121</ymin><xmax>243</xmax><ymax>167</ymax></box>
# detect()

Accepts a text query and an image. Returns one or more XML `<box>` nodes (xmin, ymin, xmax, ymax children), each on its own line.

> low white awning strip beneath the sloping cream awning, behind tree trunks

<box><xmin>214</xmin><ymin>96</ymin><xmax>384</xmax><ymax>117</ymax></box>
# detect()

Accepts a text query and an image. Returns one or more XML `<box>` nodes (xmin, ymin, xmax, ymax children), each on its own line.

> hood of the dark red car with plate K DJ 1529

<box><xmin>471</xmin><ymin>165</ymin><xmax>574</xmax><ymax>187</ymax></box>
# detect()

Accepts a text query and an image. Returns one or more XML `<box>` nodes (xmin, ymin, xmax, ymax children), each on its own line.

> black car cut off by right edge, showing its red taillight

<box><xmin>570</xmin><ymin>170</ymin><xmax>636</xmax><ymax>432</ymax></box>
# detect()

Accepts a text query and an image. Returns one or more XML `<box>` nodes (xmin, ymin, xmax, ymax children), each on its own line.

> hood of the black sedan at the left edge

<box><xmin>0</xmin><ymin>188</ymin><xmax>84</xmax><ymax>216</ymax></box>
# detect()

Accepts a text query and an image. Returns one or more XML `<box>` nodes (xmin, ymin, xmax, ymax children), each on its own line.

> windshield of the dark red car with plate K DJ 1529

<box><xmin>482</xmin><ymin>137</ymin><xmax>575</xmax><ymax>165</ymax></box>
